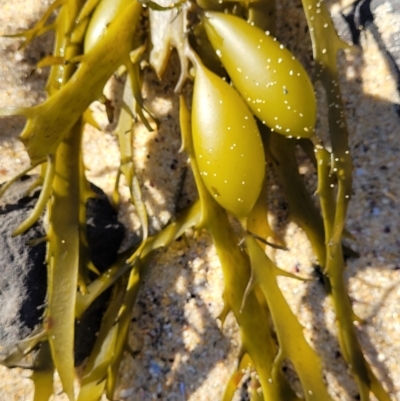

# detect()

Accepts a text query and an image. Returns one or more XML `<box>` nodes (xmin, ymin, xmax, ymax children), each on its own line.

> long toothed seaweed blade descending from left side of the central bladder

<box><xmin>180</xmin><ymin>96</ymin><xmax>298</xmax><ymax>401</ymax></box>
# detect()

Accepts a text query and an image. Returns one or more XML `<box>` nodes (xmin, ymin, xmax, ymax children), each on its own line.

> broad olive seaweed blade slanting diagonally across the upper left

<box><xmin>20</xmin><ymin>1</ymin><xmax>141</xmax><ymax>163</ymax></box>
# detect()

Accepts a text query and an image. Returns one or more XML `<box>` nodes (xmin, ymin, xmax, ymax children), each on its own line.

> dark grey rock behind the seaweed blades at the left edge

<box><xmin>0</xmin><ymin>176</ymin><xmax>125</xmax><ymax>365</ymax></box>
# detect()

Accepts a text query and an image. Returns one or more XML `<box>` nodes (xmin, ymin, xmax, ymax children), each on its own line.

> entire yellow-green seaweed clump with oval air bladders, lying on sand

<box><xmin>0</xmin><ymin>0</ymin><xmax>390</xmax><ymax>401</ymax></box>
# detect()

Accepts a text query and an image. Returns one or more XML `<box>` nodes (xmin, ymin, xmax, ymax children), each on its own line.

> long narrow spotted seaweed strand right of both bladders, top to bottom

<box><xmin>302</xmin><ymin>0</ymin><xmax>390</xmax><ymax>401</ymax></box>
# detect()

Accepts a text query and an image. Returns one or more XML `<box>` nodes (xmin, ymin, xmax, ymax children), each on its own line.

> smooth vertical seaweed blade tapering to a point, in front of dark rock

<box><xmin>45</xmin><ymin>122</ymin><xmax>81</xmax><ymax>400</ymax></box>
